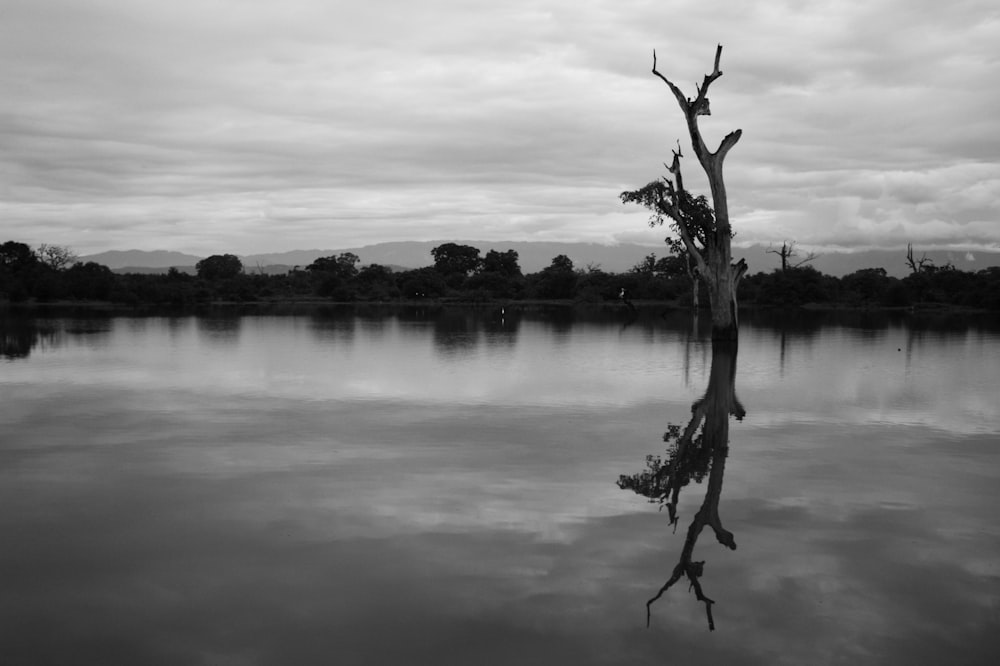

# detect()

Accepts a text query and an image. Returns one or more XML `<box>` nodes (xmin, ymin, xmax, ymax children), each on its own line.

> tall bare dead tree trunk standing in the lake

<box><xmin>653</xmin><ymin>44</ymin><xmax>747</xmax><ymax>340</ymax></box>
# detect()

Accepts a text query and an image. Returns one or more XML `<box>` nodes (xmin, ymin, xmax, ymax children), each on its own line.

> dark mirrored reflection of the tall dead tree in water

<box><xmin>618</xmin><ymin>341</ymin><xmax>746</xmax><ymax>630</ymax></box>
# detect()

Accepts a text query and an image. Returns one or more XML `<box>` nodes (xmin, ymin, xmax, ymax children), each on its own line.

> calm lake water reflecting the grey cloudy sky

<box><xmin>0</xmin><ymin>308</ymin><xmax>1000</xmax><ymax>666</ymax></box>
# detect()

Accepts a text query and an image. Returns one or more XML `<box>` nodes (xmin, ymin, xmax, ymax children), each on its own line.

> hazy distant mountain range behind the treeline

<box><xmin>79</xmin><ymin>241</ymin><xmax>1000</xmax><ymax>277</ymax></box>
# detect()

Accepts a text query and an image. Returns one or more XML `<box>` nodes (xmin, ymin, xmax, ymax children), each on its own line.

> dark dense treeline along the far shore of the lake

<box><xmin>0</xmin><ymin>241</ymin><xmax>1000</xmax><ymax>310</ymax></box>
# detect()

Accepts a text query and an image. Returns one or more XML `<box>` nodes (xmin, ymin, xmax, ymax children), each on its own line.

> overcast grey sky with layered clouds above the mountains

<box><xmin>0</xmin><ymin>0</ymin><xmax>1000</xmax><ymax>255</ymax></box>
